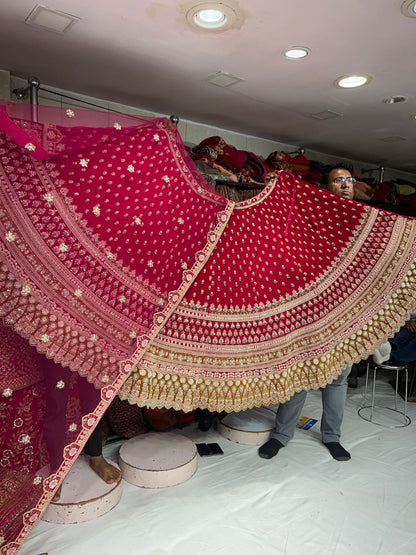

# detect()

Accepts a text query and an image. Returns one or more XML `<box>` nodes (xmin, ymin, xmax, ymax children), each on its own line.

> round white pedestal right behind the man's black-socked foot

<box><xmin>219</xmin><ymin>407</ymin><xmax>276</xmax><ymax>445</ymax></box>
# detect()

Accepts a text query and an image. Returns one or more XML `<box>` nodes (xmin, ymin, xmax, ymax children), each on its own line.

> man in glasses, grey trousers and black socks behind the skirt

<box><xmin>258</xmin><ymin>164</ymin><xmax>355</xmax><ymax>461</ymax></box>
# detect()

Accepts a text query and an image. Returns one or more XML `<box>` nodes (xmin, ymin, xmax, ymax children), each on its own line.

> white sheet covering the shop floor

<box><xmin>20</xmin><ymin>377</ymin><xmax>416</xmax><ymax>555</ymax></box>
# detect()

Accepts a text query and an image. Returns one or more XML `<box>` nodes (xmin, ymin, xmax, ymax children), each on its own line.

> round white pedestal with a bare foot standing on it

<box><xmin>42</xmin><ymin>455</ymin><xmax>122</xmax><ymax>524</ymax></box>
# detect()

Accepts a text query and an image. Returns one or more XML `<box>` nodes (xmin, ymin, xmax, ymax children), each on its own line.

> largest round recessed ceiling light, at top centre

<box><xmin>186</xmin><ymin>0</ymin><xmax>243</xmax><ymax>33</ymax></box>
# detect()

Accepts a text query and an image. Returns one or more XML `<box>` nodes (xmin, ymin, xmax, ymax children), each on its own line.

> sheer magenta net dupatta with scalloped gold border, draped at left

<box><xmin>0</xmin><ymin>103</ymin><xmax>233</xmax><ymax>554</ymax></box>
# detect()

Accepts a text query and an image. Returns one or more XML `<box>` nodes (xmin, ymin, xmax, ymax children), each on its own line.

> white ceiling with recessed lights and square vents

<box><xmin>0</xmin><ymin>0</ymin><xmax>416</xmax><ymax>172</ymax></box>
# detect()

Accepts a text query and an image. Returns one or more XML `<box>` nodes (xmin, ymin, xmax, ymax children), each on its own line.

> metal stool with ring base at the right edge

<box><xmin>358</xmin><ymin>361</ymin><xmax>411</xmax><ymax>428</ymax></box>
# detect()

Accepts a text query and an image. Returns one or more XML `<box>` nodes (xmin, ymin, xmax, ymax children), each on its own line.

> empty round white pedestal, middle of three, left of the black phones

<box><xmin>120</xmin><ymin>432</ymin><xmax>197</xmax><ymax>488</ymax></box>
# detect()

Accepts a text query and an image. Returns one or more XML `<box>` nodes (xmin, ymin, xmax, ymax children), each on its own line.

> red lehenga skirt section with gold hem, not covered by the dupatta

<box><xmin>120</xmin><ymin>172</ymin><xmax>416</xmax><ymax>411</ymax></box>
